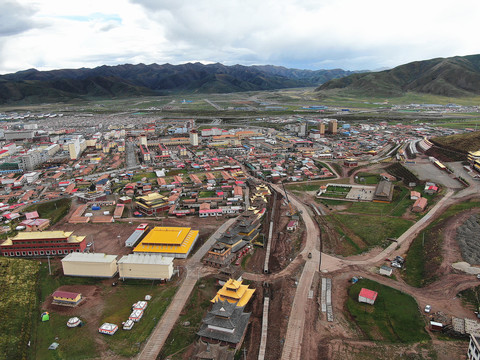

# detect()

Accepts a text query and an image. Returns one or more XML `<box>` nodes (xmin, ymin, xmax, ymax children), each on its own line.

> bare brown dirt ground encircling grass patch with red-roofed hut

<box><xmin>302</xmin><ymin>266</ymin><xmax>477</xmax><ymax>360</ymax></box>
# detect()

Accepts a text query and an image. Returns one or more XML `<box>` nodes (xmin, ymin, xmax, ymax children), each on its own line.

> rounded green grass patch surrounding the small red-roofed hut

<box><xmin>346</xmin><ymin>279</ymin><xmax>430</xmax><ymax>343</ymax></box>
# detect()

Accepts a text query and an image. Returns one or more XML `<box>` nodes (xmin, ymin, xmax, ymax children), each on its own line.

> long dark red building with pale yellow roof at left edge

<box><xmin>0</xmin><ymin>231</ymin><xmax>87</xmax><ymax>257</ymax></box>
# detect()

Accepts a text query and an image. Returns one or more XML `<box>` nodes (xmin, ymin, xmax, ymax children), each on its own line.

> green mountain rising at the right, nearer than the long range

<box><xmin>316</xmin><ymin>55</ymin><xmax>480</xmax><ymax>97</ymax></box>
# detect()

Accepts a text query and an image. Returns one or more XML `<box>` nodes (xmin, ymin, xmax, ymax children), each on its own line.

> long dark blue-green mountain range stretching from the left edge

<box><xmin>0</xmin><ymin>63</ymin><xmax>354</xmax><ymax>103</ymax></box>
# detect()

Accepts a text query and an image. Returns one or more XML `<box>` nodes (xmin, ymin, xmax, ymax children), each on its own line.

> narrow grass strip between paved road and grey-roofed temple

<box><xmin>159</xmin><ymin>278</ymin><xmax>217</xmax><ymax>360</ymax></box>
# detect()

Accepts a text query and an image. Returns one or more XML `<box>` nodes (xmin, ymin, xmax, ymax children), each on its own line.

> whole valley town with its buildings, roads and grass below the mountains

<box><xmin>0</xmin><ymin>98</ymin><xmax>480</xmax><ymax>360</ymax></box>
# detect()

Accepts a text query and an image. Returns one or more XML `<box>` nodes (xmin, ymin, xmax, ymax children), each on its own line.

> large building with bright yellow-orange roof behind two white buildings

<box><xmin>133</xmin><ymin>226</ymin><xmax>199</xmax><ymax>258</ymax></box>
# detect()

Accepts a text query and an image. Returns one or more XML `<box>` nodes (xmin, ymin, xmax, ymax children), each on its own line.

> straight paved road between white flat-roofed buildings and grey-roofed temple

<box><xmin>138</xmin><ymin>218</ymin><xmax>235</xmax><ymax>360</ymax></box>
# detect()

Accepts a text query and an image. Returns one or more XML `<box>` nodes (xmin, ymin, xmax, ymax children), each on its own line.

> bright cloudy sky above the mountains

<box><xmin>0</xmin><ymin>0</ymin><xmax>480</xmax><ymax>74</ymax></box>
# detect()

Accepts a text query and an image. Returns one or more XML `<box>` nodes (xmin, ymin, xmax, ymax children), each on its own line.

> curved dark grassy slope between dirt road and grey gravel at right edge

<box><xmin>402</xmin><ymin>201</ymin><xmax>480</xmax><ymax>287</ymax></box>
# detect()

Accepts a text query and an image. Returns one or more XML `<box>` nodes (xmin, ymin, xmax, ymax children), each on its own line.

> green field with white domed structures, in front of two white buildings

<box><xmin>31</xmin><ymin>262</ymin><xmax>177</xmax><ymax>360</ymax></box>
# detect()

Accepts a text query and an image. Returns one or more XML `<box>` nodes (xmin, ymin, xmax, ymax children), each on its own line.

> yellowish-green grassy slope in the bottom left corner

<box><xmin>0</xmin><ymin>257</ymin><xmax>40</xmax><ymax>359</ymax></box>
